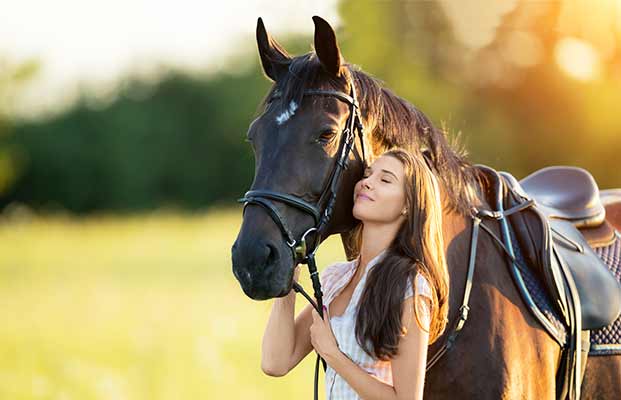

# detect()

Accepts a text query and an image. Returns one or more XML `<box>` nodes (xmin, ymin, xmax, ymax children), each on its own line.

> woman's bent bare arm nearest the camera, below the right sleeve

<box><xmin>325</xmin><ymin>296</ymin><xmax>429</xmax><ymax>400</ymax></box>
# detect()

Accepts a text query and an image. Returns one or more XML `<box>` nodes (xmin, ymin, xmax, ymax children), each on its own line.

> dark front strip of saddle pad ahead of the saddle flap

<box><xmin>510</xmin><ymin>231</ymin><xmax>567</xmax><ymax>347</ymax></box>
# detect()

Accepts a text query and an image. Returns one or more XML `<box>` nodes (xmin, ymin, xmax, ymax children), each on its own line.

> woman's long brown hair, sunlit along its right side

<box><xmin>351</xmin><ymin>148</ymin><xmax>449</xmax><ymax>360</ymax></box>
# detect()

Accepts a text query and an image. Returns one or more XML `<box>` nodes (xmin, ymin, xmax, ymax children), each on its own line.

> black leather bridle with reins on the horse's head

<box><xmin>237</xmin><ymin>82</ymin><xmax>367</xmax><ymax>400</ymax></box>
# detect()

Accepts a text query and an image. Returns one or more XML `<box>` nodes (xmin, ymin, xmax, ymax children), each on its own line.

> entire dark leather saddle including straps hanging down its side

<box><xmin>477</xmin><ymin>164</ymin><xmax>621</xmax><ymax>399</ymax></box>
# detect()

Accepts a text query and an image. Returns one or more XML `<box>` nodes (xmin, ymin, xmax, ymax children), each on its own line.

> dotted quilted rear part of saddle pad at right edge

<box><xmin>589</xmin><ymin>232</ymin><xmax>621</xmax><ymax>356</ymax></box>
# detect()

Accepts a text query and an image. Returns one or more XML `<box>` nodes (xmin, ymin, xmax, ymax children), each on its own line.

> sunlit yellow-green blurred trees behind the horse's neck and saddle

<box><xmin>339</xmin><ymin>0</ymin><xmax>621</xmax><ymax>188</ymax></box>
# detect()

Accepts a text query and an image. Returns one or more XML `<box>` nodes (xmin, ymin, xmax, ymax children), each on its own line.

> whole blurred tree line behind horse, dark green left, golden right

<box><xmin>0</xmin><ymin>0</ymin><xmax>621</xmax><ymax>216</ymax></box>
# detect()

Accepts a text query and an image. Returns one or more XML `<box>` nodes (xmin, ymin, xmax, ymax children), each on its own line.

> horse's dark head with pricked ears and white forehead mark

<box><xmin>232</xmin><ymin>17</ymin><xmax>364</xmax><ymax>300</ymax></box>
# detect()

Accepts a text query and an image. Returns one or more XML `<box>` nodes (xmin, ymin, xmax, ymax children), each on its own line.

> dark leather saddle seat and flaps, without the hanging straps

<box><xmin>500</xmin><ymin>166</ymin><xmax>621</xmax><ymax>330</ymax></box>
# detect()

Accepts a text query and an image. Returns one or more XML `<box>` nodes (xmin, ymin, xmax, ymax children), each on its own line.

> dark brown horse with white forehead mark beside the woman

<box><xmin>232</xmin><ymin>17</ymin><xmax>621</xmax><ymax>399</ymax></box>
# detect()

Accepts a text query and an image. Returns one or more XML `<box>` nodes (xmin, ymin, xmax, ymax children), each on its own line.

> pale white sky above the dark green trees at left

<box><xmin>0</xmin><ymin>0</ymin><xmax>339</xmax><ymax>117</ymax></box>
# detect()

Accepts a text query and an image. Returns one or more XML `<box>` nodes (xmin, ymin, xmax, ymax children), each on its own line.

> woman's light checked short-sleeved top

<box><xmin>320</xmin><ymin>249</ymin><xmax>431</xmax><ymax>400</ymax></box>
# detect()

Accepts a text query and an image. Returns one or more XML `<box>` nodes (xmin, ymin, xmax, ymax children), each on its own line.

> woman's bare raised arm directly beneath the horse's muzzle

<box><xmin>261</xmin><ymin>266</ymin><xmax>313</xmax><ymax>376</ymax></box>
